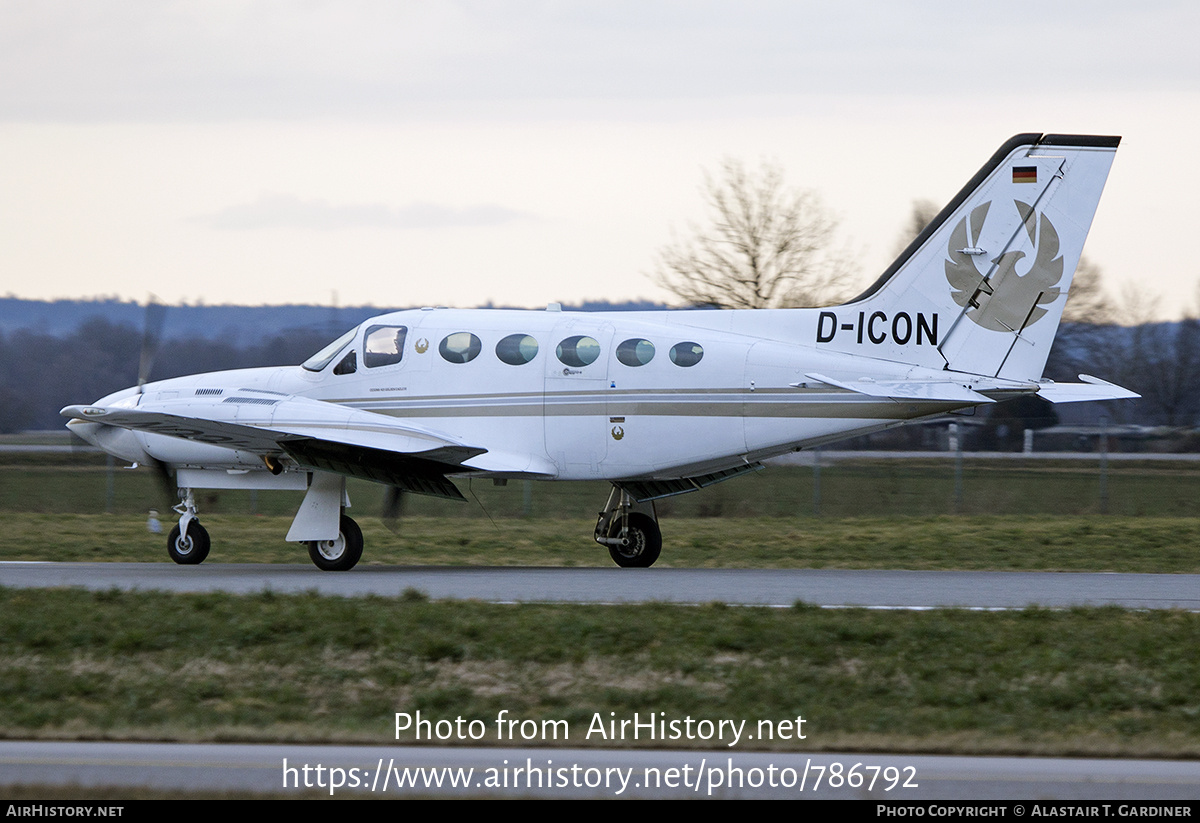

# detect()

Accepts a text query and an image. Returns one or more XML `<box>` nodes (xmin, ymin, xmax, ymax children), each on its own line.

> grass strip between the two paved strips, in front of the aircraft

<box><xmin>0</xmin><ymin>589</ymin><xmax>1200</xmax><ymax>757</ymax></box>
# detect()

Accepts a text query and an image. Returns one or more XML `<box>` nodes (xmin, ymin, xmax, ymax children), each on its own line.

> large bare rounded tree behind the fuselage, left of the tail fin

<box><xmin>654</xmin><ymin>158</ymin><xmax>854</xmax><ymax>308</ymax></box>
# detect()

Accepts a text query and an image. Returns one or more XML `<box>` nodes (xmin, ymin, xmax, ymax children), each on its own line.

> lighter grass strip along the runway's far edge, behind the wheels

<box><xmin>7</xmin><ymin>513</ymin><xmax>1200</xmax><ymax>573</ymax></box>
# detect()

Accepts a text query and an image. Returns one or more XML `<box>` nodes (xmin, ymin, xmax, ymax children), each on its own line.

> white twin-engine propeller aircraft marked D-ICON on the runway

<box><xmin>62</xmin><ymin>134</ymin><xmax>1136</xmax><ymax>571</ymax></box>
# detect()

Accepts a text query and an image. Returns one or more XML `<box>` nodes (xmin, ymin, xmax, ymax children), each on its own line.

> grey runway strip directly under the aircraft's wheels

<box><xmin>0</xmin><ymin>561</ymin><xmax>1200</xmax><ymax>611</ymax></box>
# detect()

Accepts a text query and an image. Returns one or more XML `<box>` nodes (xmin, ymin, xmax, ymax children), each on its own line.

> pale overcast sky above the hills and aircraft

<box><xmin>0</xmin><ymin>0</ymin><xmax>1200</xmax><ymax>316</ymax></box>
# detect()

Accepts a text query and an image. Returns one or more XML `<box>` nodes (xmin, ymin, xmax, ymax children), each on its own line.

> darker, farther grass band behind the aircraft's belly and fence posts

<box><xmin>9</xmin><ymin>453</ymin><xmax>1200</xmax><ymax>519</ymax></box>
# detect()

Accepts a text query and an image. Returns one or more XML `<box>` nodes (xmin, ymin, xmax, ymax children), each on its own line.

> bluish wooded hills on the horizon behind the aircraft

<box><xmin>0</xmin><ymin>298</ymin><xmax>1161</xmax><ymax>432</ymax></box>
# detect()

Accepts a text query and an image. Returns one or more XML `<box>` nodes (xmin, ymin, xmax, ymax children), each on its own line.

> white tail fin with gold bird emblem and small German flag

<box><xmin>817</xmin><ymin>134</ymin><xmax>1121</xmax><ymax>380</ymax></box>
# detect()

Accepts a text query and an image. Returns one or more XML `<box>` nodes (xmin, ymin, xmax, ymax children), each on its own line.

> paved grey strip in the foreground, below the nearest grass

<box><xmin>7</xmin><ymin>741</ymin><xmax>1200</xmax><ymax>801</ymax></box>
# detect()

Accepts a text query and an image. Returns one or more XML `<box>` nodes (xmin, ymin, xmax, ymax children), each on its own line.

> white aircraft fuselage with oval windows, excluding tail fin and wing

<box><xmin>102</xmin><ymin>308</ymin><xmax>970</xmax><ymax>480</ymax></box>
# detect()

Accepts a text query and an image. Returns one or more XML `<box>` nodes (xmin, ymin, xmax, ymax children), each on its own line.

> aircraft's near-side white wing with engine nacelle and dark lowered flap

<box><xmin>61</xmin><ymin>389</ymin><xmax>546</xmax><ymax>499</ymax></box>
